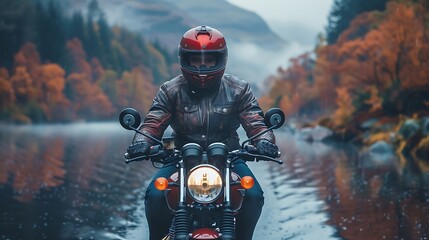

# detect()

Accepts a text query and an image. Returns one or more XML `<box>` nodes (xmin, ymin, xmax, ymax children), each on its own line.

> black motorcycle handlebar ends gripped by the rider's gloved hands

<box><xmin>124</xmin><ymin>145</ymin><xmax>283</xmax><ymax>164</ymax></box>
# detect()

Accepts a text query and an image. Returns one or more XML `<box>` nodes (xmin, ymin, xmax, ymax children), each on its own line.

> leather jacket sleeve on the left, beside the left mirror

<box><xmin>134</xmin><ymin>85</ymin><xmax>173</xmax><ymax>144</ymax></box>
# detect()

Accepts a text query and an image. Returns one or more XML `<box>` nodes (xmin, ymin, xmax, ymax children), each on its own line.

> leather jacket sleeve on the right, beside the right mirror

<box><xmin>238</xmin><ymin>83</ymin><xmax>276</xmax><ymax>143</ymax></box>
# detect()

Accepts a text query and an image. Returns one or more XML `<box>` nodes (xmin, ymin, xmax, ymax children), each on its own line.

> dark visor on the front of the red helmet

<box><xmin>181</xmin><ymin>51</ymin><xmax>225</xmax><ymax>74</ymax></box>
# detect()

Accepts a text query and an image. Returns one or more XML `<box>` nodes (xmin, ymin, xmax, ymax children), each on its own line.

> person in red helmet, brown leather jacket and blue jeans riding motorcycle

<box><xmin>127</xmin><ymin>26</ymin><xmax>278</xmax><ymax>240</ymax></box>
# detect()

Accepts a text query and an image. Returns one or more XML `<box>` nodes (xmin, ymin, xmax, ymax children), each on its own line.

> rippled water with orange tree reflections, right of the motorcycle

<box><xmin>264</xmin><ymin>132</ymin><xmax>429</xmax><ymax>239</ymax></box>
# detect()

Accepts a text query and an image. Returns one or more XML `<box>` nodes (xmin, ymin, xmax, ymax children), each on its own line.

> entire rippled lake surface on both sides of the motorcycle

<box><xmin>0</xmin><ymin>123</ymin><xmax>429</xmax><ymax>240</ymax></box>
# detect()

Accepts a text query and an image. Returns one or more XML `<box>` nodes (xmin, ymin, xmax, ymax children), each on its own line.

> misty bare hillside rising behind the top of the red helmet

<box><xmin>45</xmin><ymin>0</ymin><xmax>285</xmax><ymax>49</ymax></box>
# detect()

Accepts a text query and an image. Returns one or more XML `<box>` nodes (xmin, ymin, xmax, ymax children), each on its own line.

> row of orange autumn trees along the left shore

<box><xmin>0</xmin><ymin>38</ymin><xmax>156</xmax><ymax>123</ymax></box>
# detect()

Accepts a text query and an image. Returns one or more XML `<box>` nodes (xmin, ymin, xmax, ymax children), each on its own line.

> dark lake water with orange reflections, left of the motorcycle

<box><xmin>0</xmin><ymin>123</ymin><xmax>153</xmax><ymax>239</ymax></box>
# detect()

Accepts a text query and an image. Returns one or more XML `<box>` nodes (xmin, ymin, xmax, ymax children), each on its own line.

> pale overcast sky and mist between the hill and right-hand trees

<box><xmin>222</xmin><ymin>0</ymin><xmax>334</xmax><ymax>85</ymax></box>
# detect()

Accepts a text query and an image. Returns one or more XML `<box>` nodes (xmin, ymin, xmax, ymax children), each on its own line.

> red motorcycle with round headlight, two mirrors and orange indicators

<box><xmin>119</xmin><ymin>108</ymin><xmax>285</xmax><ymax>240</ymax></box>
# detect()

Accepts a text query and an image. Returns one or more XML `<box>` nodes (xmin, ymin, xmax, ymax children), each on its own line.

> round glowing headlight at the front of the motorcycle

<box><xmin>187</xmin><ymin>165</ymin><xmax>223</xmax><ymax>203</ymax></box>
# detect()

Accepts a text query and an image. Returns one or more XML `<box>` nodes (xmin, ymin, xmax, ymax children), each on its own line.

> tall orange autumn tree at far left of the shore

<box><xmin>6</xmin><ymin>43</ymin><xmax>73</xmax><ymax>122</ymax></box>
